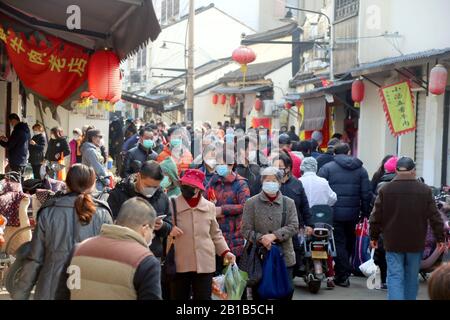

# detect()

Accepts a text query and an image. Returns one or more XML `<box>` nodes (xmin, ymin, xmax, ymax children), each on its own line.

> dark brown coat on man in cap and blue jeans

<box><xmin>370</xmin><ymin>177</ymin><xmax>444</xmax><ymax>252</ymax></box>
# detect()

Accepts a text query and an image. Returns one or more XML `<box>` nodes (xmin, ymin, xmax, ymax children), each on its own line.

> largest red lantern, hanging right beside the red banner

<box><xmin>88</xmin><ymin>50</ymin><xmax>122</xmax><ymax>102</ymax></box>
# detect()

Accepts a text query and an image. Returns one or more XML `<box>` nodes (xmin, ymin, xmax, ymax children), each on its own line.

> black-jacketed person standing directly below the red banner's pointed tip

<box><xmin>45</xmin><ymin>127</ymin><xmax>70</xmax><ymax>181</ymax></box>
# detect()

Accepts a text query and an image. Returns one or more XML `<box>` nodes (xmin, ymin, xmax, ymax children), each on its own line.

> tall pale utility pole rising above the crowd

<box><xmin>184</xmin><ymin>0</ymin><xmax>195</xmax><ymax>122</ymax></box>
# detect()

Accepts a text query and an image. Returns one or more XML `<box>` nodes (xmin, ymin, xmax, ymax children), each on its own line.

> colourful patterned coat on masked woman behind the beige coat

<box><xmin>207</xmin><ymin>173</ymin><xmax>250</xmax><ymax>256</ymax></box>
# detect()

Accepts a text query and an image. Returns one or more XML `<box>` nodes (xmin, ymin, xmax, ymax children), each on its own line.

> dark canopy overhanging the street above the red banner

<box><xmin>0</xmin><ymin>0</ymin><xmax>161</xmax><ymax>60</ymax></box>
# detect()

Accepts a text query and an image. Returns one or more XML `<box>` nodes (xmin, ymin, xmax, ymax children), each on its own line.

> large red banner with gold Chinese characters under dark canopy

<box><xmin>0</xmin><ymin>25</ymin><xmax>89</xmax><ymax>105</ymax></box>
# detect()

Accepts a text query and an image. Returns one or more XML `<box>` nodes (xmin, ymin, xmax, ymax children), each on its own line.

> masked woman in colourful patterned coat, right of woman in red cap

<box><xmin>207</xmin><ymin>148</ymin><xmax>250</xmax><ymax>273</ymax></box>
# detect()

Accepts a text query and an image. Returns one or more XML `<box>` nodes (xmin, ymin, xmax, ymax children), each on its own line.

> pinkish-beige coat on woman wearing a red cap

<box><xmin>175</xmin><ymin>195</ymin><xmax>229</xmax><ymax>273</ymax></box>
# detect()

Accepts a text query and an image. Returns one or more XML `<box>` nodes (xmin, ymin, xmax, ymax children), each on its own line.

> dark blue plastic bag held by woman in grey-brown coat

<box><xmin>258</xmin><ymin>245</ymin><xmax>293</xmax><ymax>300</ymax></box>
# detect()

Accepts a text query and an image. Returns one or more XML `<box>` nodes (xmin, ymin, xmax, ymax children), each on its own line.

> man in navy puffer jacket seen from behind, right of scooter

<box><xmin>318</xmin><ymin>143</ymin><xmax>370</xmax><ymax>287</ymax></box>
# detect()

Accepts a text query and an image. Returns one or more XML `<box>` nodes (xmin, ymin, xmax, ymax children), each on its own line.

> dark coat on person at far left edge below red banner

<box><xmin>0</xmin><ymin>122</ymin><xmax>31</xmax><ymax>166</ymax></box>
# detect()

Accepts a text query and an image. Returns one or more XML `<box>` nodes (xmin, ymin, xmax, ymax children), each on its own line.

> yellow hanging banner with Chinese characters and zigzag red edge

<box><xmin>380</xmin><ymin>81</ymin><xmax>416</xmax><ymax>137</ymax></box>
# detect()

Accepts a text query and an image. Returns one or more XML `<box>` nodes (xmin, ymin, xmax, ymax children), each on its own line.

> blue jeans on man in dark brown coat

<box><xmin>386</xmin><ymin>252</ymin><xmax>422</xmax><ymax>300</ymax></box>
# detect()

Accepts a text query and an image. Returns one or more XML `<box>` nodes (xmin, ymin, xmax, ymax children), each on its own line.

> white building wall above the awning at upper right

<box><xmin>359</xmin><ymin>0</ymin><xmax>450</xmax><ymax>63</ymax></box>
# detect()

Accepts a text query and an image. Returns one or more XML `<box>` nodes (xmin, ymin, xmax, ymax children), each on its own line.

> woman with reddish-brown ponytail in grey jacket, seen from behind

<box><xmin>10</xmin><ymin>164</ymin><xmax>112</xmax><ymax>300</ymax></box>
